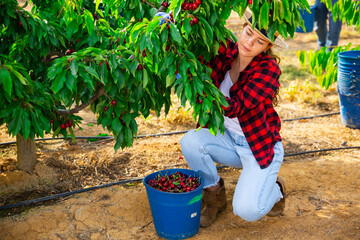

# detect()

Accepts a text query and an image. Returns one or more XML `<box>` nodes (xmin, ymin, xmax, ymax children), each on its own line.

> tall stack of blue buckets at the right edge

<box><xmin>337</xmin><ymin>51</ymin><xmax>360</xmax><ymax>128</ymax></box>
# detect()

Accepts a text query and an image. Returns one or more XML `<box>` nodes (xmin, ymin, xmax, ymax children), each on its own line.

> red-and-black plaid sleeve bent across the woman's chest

<box><xmin>224</xmin><ymin>60</ymin><xmax>280</xmax><ymax>118</ymax></box>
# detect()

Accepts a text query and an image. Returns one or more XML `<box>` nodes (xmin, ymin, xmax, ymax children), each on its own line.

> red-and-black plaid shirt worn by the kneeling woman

<box><xmin>202</xmin><ymin>39</ymin><xmax>281</xmax><ymax>169</ymax></box>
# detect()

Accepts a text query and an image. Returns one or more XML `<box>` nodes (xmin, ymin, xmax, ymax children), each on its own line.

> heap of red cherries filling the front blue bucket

<box><xmin>147</xmin><ymin>171</ymin><xmax>201</xmax><ymax>193</ymax></box>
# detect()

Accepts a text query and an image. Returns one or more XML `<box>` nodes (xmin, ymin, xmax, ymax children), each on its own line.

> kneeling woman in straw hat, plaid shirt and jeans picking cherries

<box><xmin>180</xmin><ymin>8</ymin><xmax>287</xmax><ymax>227</ymax></box>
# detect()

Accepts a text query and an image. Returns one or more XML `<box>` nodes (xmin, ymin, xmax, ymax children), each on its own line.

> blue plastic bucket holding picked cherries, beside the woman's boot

<box><xmin>143</xmin><ymin>168</ymin><xmax>204</xmax><ymax>239</ymax></box>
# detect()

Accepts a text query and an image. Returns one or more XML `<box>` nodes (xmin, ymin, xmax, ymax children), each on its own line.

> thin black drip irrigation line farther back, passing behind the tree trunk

<box><xmin>0</xmin><ymin>112</ymin><xmax>340</xmax><ymax>146</ymax></box>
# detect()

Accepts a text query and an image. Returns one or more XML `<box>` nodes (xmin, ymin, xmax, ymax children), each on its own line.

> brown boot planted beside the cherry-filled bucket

<box><xmin>200</xmin><ymin>178</ymin><xmax>227</xmax><ymax>227</ymax></box>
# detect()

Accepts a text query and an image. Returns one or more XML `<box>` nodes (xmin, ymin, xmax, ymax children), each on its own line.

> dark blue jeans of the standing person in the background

<box><xmin>314</xmin><ymin>0</ymin><xmax>342</xmax><ymax>51</ymax></box>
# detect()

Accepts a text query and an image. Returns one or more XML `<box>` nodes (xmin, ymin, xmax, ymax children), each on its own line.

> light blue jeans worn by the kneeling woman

<box><xmin>180</xmin><ymin>128</ymin><xmax>284</xmax><ymax>221</ymax></box>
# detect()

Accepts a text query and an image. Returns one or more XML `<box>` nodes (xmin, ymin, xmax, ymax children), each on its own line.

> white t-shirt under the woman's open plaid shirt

<box><xmin>219</xmin><ymin>71</ymin><xmax>244</xmax><ymax>136</ymax></box>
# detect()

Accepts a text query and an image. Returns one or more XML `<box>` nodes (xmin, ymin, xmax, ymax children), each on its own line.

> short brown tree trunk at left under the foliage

<box><xmin>16</xmin><ymin>134</ymin><xmax>36</xmax><ymax>173</ymax></box>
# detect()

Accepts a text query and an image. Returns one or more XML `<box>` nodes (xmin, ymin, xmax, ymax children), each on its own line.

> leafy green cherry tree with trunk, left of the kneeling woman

<box><xmin>0</xmin><ymin>0</ymin><xmax>309</xmax><ymax>171</ymax></box>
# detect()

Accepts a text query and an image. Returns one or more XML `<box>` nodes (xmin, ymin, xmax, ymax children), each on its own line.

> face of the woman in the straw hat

<box><xmin>238</xmin><ymin>25</ymin><xmax>271</xmax><ymax>58</ymax></box>
